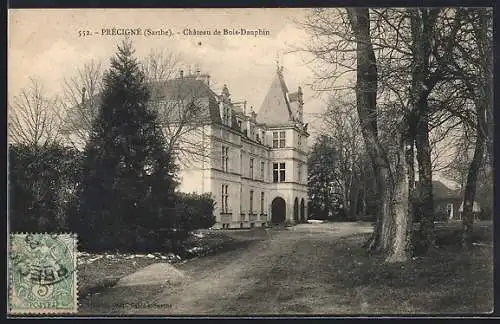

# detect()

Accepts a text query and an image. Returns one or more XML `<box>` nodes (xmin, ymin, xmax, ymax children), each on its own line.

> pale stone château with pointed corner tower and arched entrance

<box><xmin>174</xmin><ymin>68</ymin><xmax>309</xmax><ymax>228</ymax></box>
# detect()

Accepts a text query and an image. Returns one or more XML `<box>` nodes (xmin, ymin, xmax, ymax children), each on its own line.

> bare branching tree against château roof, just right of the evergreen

<box><xmin>142</xmin><ymin>50</ymin><xmax>218</xmax><ymax>170</ymax></box>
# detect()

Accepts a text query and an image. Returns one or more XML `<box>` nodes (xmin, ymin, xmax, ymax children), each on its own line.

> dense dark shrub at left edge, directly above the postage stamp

<box><xmin>9</xmin><ymin>144</ymin><xmax>80</xmax><ymax>232</ymax></box>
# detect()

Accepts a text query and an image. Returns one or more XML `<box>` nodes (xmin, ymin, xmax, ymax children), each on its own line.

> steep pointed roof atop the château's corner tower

<box><xmin>257</xmin><ymin>68</ymin><xmax>298</xmax><ymax>125</ymax></box>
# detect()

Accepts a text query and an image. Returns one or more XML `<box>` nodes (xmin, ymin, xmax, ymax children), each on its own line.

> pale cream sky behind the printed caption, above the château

<box><xmin>8</xmin><ymin>8</ymin><xmax>325</xmax><ymax>137</ymax></box>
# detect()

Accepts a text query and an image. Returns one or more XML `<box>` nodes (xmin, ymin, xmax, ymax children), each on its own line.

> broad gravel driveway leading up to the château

<box><xmin>80</xmin><ymin>223</ymin><xmax>371</xmax><ymax>315</ymax></box>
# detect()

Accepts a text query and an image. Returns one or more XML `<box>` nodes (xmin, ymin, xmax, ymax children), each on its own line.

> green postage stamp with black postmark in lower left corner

<box><xmin>9</xmin><ymin>233</ymin><xmax>78</xmax><ymax>314</ymax></box>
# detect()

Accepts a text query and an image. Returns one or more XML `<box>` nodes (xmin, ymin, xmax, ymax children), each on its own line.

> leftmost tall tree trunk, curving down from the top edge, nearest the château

<box><xmin>346</xmin><ymin>7</ymin><xmax>391</xmax><ymax>250</ymax></box>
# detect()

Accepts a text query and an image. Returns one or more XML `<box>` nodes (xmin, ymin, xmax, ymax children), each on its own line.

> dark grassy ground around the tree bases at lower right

<box><xmin>326</xmin><ymin>227</ymin><xmax>493</xmax><ymax>314</ymax></box>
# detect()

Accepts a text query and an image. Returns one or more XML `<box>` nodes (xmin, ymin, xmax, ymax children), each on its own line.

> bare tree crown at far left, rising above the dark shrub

<box><xmin>8</xmin><ymin>78</ymin><xmax>61</xmax><ymax>148</ymax></box>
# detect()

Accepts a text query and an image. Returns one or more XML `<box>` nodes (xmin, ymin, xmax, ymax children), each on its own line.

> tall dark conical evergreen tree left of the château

<box><xmin>77</xmin><ymin>41</ymin><xmax>177</xmax><ymax>250</ymax></box>
